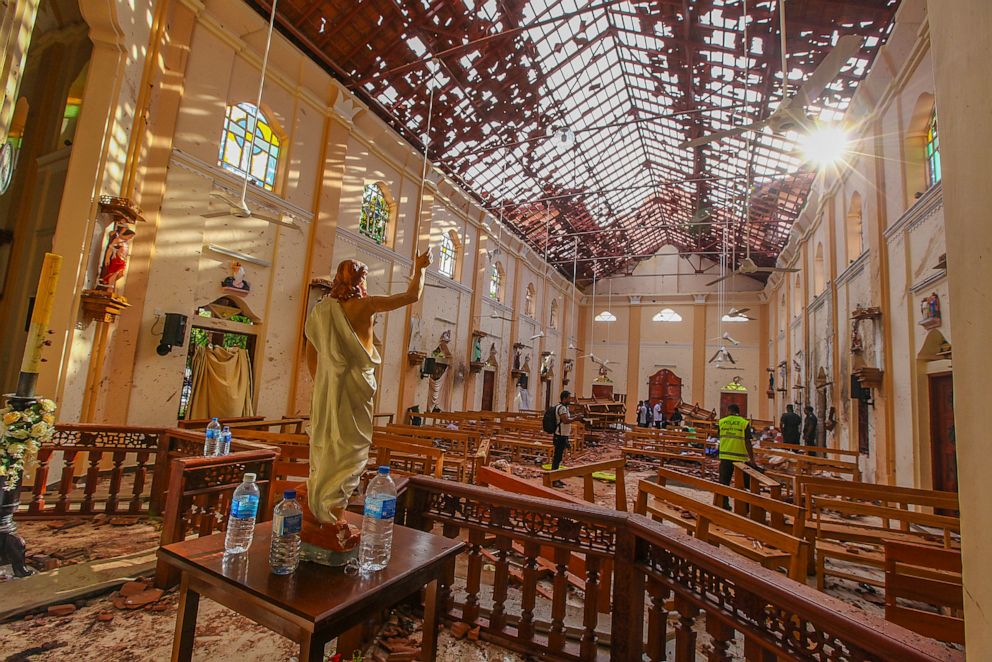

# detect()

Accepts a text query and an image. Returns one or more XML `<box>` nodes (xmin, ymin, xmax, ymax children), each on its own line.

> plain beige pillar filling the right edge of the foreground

<box><xmin>928</xmin><ymin>0</ymin><xmax>992</xmax><ymax>659</ymax></box>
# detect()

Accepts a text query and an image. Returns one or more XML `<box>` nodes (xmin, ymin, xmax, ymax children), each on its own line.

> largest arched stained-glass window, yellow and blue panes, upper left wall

<box><xmin>218</xmin><ymin>103</ymin><xmax>281</xmax><ymax>191</ymax></box>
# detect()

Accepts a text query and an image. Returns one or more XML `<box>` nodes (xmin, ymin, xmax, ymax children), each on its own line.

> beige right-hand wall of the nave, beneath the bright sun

<box><xmin>766</xmin><ymin>0</ymin><xmax>951</xmax><ymax>487</ymax></box>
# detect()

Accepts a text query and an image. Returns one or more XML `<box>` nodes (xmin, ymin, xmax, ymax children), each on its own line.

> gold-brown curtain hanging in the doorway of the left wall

<box><xmin>186</xmin><ymin>346</ymin><xmax>255</xmax><ymax>418</ymax></box>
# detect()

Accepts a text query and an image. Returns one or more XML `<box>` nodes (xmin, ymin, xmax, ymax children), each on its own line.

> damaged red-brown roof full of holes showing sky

<box><xmin>251</xmin><ymin>0</ymin><xmax>899</xmax><ymax>278</ymax></box>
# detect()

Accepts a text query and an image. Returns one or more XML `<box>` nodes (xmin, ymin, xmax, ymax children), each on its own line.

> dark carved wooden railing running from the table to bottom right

<box><xmin>406</xmin><ymin>476</ymin><xmax>963</xmax><ymax>662</ymax></box>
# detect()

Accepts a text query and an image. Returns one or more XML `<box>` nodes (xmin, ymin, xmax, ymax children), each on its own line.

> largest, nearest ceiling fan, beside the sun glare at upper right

<box><xmin>679</xmin><ymin>29</ymin><xmax>865</xmax><ymax>149</ymax></box>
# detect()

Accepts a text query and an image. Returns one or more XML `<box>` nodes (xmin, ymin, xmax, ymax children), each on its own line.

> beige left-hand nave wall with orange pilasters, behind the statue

<box><xmin>33</xmin><ymin>0</ymin><xmax>574</xmax><ymax>424</ymax></box>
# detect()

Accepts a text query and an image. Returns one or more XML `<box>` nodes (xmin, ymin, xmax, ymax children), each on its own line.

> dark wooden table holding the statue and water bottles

<box><xmin>158</xmin><ymin>513</ymin><xmax>465</xmax><ymax>662</ymax></box>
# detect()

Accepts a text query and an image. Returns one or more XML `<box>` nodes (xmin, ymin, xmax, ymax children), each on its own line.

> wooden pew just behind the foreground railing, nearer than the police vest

<box><xmin>634</xmin><ymin>475</ymin><xmax>809</xmax><ymax>582</ymax></box>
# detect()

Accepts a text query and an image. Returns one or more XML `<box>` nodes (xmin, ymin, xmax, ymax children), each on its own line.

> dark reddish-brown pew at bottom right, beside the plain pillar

<box><xmin>885</xmin><ymin>540</ymin><xmax>964</xmax><ymax>644</ymax></box>
